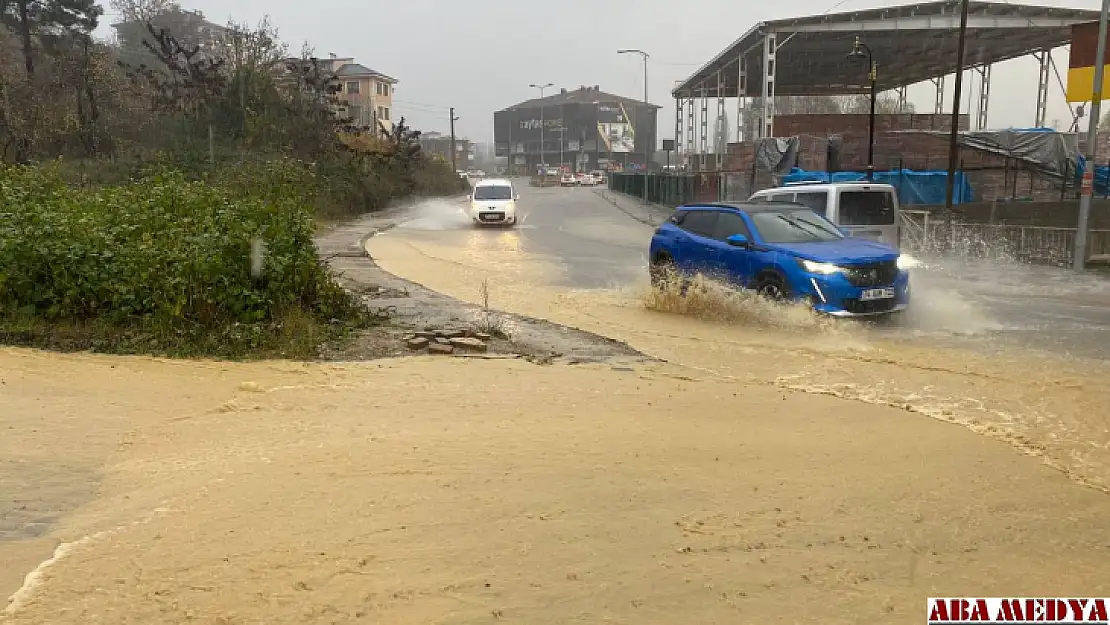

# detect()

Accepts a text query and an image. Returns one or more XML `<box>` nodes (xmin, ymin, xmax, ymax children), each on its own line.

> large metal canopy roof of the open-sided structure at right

<box><xmin>672</xmin><ymin>0</ymin><xmax>1099</xmax><ymax>98</ymax></box>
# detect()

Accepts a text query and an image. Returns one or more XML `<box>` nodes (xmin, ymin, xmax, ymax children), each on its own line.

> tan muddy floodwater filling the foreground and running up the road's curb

<box><xmin>0</xmin><ymin>194</ymin><xmax>1110</xmax><ymax>625</ymax></box>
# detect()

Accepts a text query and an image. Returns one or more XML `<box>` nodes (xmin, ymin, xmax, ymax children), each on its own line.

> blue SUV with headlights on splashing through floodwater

<box><xmin>648</xmin><ymin>202</ymin><xmax>909</xmax><ymax>316</ymax></box>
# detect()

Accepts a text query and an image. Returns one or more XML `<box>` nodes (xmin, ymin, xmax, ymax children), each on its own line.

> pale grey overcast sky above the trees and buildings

<box><xmin>103</xmin><ymin>0</ymin><xmax>1099</xmax><ymax>141</ymax></box>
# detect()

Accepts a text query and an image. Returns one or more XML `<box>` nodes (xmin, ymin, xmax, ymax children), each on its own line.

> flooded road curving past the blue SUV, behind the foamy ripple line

<box><xmin>369</xmin><ymin>189</ymin><xmax>1110</xmax><ymax>490</ymax></box>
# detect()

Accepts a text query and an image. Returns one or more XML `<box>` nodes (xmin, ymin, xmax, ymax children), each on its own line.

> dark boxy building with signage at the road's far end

<box><xmin>494</xmin><ymin>85</ymin><xmax>659</xmax><ymax>174</ymax></box>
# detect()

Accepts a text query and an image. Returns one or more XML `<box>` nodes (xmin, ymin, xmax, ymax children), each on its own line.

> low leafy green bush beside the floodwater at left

<box><xmin>0</xmin><ymin>161</ymin><xmax>370</xmax><ymax>355</ymax></box>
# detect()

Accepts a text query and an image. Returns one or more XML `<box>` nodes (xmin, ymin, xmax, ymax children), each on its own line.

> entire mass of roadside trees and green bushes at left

<box><xmin>0</xmin><ymin>0</ymin><xmax>465</xmax><ymax>357</ymax></box>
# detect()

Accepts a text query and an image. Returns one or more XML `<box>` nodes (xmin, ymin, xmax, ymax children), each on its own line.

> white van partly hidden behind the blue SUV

<box><xmin>750</xmin><ymin>182</ymin><xmax>901</xmax><ymax>248</ymax></box>
